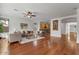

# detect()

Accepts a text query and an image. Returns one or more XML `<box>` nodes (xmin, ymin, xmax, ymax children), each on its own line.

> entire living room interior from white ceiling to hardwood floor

<box><xmin>0</xmin><ymin>3</ymin><xmax>79</xmax><ymax>55</ymax></box>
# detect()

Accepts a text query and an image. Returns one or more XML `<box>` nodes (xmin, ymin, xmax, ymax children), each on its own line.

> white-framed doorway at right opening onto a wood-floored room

<box><xmin>66</xmin><ymin>22</ymin><xmax>77</xmax><ymax>48</ymax></box>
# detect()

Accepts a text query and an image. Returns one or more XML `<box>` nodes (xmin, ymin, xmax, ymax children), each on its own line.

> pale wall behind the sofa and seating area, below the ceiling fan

<box><xmin>1</xmin><ymin>13</ymin><xmax>50</xmax><ymax>33</ymax></box>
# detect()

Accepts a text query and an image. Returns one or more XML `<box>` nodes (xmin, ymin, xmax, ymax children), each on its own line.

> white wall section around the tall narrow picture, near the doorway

<box><xmin>50</xmin><ymin>15</ymin><xmax>76</xmax><ymax>37</ymax></box>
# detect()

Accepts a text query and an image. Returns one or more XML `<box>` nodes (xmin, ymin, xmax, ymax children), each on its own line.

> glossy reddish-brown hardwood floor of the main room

<box><xmin>10</xmin><ymin>36</ymin><xmax>79</xmax><ymax>55</ymax></box>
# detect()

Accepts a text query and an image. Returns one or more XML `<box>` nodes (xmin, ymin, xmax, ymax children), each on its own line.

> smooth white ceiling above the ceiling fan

<box><xmin>0</xmin><ymin>3</ymin><xmax>79</xmax><ymax>20</ymax></box>
